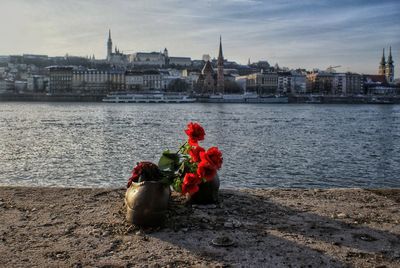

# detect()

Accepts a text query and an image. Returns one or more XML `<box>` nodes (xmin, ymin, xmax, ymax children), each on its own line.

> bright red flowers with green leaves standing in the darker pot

<box><xmin>158</xmin><ymin>122</ymin><xmax>223</xmax><ymax>195</ymax></box>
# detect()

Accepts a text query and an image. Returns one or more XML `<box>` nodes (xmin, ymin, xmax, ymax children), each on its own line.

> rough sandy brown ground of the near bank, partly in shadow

<box><xmin>0</xmin><ymin>187</ymin><xmax>400</xmax><ymax>267</ymax></box>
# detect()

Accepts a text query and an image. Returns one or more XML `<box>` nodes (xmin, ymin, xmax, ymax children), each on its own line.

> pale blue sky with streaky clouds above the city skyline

<box><xmin>0</xmin><ymin>0</ymin><xmax>400</xmax><ymax>74</ymax></box>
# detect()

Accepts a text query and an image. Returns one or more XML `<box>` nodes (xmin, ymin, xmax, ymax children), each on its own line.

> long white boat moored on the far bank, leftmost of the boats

<box><xmin>102</xmin><ymin>93</ymin><xmax>196</xmax><ymax>103</ymax></box>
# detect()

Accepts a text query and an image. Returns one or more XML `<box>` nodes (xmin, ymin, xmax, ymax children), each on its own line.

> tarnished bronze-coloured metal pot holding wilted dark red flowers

<box><xmin>125</xmin><ymin>181</ymin><xmax>171</xmax><ymax>226</ymax></box>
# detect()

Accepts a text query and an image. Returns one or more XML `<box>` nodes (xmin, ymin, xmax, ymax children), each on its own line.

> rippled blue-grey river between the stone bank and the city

<box><xmin>0</xmin><ymin>102</ymin><xmax>400</xmax><ymax>188</ymax></box>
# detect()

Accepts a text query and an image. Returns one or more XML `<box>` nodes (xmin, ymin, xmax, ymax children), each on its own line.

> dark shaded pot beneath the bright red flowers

<box><xmin>188</xmin><ymin>174</ymin><xmax>219</xmax><ymax>204</ymax></box>
